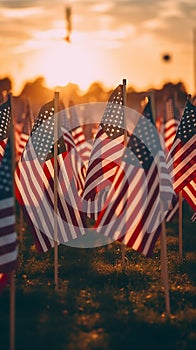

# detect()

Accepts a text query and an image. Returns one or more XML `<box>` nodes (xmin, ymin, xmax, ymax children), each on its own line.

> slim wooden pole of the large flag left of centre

<box><xmin>54</xmin><ymin>91</ymin><xmax>59</xmax><ymax>291</ymax></box>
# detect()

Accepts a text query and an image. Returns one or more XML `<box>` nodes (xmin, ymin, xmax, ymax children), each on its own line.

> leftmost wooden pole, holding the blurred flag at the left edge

<box><xmin>10</xmin><ymin>93</ymin><xmax>16</xmax><ymax>350</ymax></box>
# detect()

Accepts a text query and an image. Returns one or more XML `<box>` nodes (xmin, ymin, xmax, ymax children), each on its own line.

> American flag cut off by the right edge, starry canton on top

<box><xmin>168</xmin><ymin>100</ymin><xmax>196</xmax><ymax>193</ymax></box>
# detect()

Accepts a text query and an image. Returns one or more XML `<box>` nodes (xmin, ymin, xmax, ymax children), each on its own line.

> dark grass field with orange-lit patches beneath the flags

<box><xmin>0</xmin><ymin>203</ymin><xmax>196</xmax><ymax>350</ymax></box>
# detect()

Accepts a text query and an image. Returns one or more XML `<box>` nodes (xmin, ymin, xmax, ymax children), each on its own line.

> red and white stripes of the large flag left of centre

<box><xmin>15</xmin><ymin>141</ymin><xmax>85</xmax><ymax>252</ymax></box>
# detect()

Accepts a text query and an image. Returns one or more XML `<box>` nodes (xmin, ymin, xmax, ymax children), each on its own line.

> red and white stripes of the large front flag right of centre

<box><xmin>96</xmin><ymin>153</ymin><xmax>161</xmax><ymax>256</ymax></box>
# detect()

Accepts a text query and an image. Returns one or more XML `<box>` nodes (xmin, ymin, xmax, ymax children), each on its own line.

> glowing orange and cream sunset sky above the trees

<box><xmin>0</xmin><ymin>0</ymin><xmax>196</xmax><ymax>94</ymax></box>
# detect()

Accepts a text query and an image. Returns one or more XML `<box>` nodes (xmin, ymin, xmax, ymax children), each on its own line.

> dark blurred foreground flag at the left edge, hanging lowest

<box><xmin>0</xmin><ymin>135</ymin><xmax>18</xmax><ymax>273</ymax></box>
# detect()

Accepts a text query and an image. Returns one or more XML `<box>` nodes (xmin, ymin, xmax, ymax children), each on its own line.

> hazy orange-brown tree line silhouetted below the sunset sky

<box><xmin>0</xmin><ymin>76</ymin><xmax>189</xmax><ymax>122</ymax></box>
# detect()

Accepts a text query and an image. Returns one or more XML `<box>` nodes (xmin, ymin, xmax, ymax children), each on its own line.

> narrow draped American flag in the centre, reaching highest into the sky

<box><xmin>83</xmin><ymin>85</ymin><xmax>124</xmax><ymax>219</ymax></box>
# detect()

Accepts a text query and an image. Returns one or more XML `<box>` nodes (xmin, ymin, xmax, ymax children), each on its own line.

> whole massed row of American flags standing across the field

<box><xmin>0</xmin><ymin>84</ymin><xmax>196</xmax><ymax>284</ymax></box>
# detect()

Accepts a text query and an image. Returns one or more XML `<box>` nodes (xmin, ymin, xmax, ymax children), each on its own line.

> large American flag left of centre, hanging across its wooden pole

<box><xmin>15</xmin><ymin>101</ymin><xmax>85</xmax><ymax>252</ymax></box>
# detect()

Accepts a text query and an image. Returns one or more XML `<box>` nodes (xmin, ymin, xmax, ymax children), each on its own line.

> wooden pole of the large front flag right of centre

<box><xmin>150</xmin><ymin>91</ymin><xmax>170</xmax><ymax>316</ymax></box>
